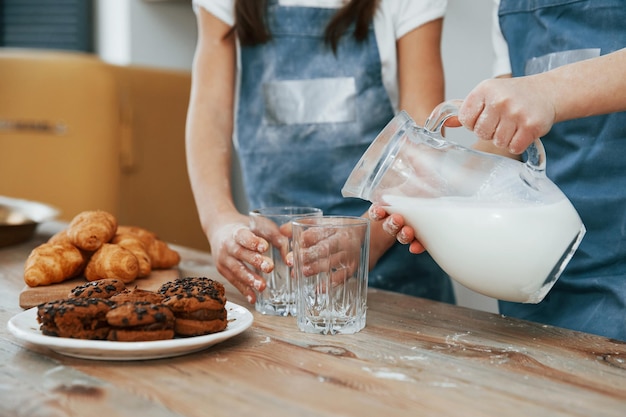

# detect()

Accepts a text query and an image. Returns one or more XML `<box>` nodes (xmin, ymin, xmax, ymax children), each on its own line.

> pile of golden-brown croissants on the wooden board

<box><xmin>24</xmin><ymin>210</ymin><xmax>180</xmax><ymax>287</ymax></box>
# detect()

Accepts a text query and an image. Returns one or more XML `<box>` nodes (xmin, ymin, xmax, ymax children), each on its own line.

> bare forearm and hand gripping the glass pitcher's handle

<box><xmin>458</xmin><ymin>49</ymin><xmax>626</xmax><ymax>154</ymax></box>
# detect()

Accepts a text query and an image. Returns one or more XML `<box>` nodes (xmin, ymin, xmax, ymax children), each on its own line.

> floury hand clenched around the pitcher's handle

<box><xmin>445</xmin><ymin>76</ymin><xmax>556</xmax><ymax>154</ymax></box>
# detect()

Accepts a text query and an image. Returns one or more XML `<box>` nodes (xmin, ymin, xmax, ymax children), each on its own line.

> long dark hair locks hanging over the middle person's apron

<box><xmin>233</xmin><ymin>0</ymin><xmax>379</xmax><ymax>52</ymax></box>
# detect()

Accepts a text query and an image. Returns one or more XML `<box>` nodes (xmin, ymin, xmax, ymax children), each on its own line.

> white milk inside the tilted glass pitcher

<box><xmin>384</xmin><ymin>196</ymin><xmax>582</xmax><ymax>303</ymax></box>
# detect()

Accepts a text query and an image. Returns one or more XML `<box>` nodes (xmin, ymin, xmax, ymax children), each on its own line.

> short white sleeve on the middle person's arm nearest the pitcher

<box><xmin>389</xmin><ymin>0</ymin><xmax>448</xmax><ymax>39</ymax></box>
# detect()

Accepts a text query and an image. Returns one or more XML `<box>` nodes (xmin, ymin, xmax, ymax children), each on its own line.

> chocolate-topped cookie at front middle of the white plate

<box><xmin>106</xmin><ymin>301</ymin><xmax>174</xmax><ymax>342</ymax></box>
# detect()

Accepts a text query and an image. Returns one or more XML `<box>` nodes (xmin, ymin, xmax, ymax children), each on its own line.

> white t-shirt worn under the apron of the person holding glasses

<box><xmin>193</xmin><ymin>0</ymin><xmax>447</xmax><ymax>112</ymax></box>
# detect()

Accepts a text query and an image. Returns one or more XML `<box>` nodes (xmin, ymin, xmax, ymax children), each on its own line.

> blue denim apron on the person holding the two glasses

<box><xmin>236</xmin><ymin>1</ymin><xmax>454</xmax><ymax>302</ymax></box>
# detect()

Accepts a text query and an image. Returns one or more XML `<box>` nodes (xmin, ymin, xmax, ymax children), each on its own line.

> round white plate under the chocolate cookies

<box><xmin>7</xmin><ymin>301</ymin><xmax>254</xmax><ymax>361</ymax></box>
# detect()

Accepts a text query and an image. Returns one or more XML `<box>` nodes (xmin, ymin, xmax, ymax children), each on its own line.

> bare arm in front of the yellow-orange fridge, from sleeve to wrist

<box><xmin>186</xmin><ymin>10</ymin><xmax>236</xmax><ymax>236</ymax></box>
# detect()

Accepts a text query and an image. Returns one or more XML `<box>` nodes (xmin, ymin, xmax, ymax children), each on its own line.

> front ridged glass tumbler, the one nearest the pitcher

<box><xmin>293</xmin><ymin>216</ymin><xmax>370</xmax><ymax>334</ymax></box>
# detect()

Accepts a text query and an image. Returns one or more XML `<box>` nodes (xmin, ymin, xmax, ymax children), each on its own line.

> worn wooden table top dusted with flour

<box><xmin>0</xmin><ymin>221</ymin><xmax>626</xmax><ymax>417</ymax></box>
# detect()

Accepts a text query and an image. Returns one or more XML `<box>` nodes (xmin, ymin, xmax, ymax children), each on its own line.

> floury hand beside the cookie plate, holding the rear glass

<box><xmin>209</xmin><ymin>214</ymin><xmax>274</xmax><ymax>304</ymax></box>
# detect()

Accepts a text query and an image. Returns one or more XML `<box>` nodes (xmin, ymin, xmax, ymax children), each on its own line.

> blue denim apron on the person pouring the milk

<box><xmin>499</xmin><ymin>0</ymin><xmax>626</xmax><ymax>340</ymax></box>
